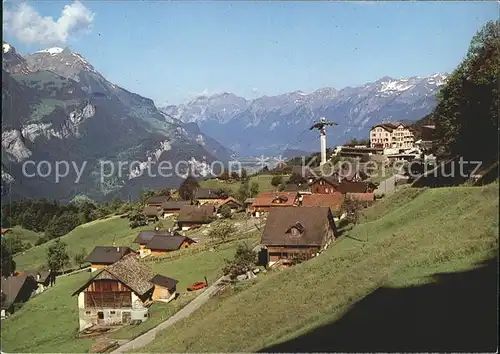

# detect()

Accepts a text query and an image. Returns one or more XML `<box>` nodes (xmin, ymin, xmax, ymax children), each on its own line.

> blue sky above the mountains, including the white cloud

<box><xmin>3</xmin><ymin>0</ymin><xmax>499</xmax><ymax>105</ymax></box>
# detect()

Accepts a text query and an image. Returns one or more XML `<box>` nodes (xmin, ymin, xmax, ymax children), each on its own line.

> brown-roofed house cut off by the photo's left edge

<box><xmin>0</xmin><ymin>275</ymin><xmax>38</xmax><ymax>318</ymax></box>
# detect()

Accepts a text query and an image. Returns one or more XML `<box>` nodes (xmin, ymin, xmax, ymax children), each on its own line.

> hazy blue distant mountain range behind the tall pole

<box><xmin>160</xmin><ymin>74</ymin><xmax>448</xmax><ymax>156</ymax></box>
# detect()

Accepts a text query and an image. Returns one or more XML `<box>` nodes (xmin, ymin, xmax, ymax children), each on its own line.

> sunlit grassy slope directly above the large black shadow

<box><xmin>141</xmin><ymin>184</ymin><xmax>498</xmax><ymax>352</ymax></box>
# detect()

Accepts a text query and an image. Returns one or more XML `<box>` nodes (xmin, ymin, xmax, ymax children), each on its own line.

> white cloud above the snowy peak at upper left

<box><xmin>3</xmin><ymin>1</ymin><xmax>94</xmax><ymax>45</ymax></box>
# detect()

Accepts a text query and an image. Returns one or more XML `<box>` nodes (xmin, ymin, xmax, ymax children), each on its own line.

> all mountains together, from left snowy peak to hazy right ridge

<box><xmin>2</xmin><ymin>42</ymin><xmax>447</xmax><ymax>201</ymax></box>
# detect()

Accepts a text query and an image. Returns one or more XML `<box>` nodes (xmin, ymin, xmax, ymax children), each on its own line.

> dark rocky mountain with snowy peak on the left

<box><xmin>2</xmin><ymin>42</ymin><xmax>231</xmax><ymax>200</ymax></box>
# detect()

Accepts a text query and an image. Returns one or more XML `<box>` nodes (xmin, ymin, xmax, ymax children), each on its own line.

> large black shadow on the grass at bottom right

<box><xmin>261</xmin><ymin>257</ymin><xmax>498</xmax><ymax>352</ymax></box>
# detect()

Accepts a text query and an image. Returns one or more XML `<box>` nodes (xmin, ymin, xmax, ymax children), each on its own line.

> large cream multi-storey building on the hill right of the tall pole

<box><xmin>370</xmin><ymin>122</ymin><xmax>414</xmax><ymax>149</ymax></box>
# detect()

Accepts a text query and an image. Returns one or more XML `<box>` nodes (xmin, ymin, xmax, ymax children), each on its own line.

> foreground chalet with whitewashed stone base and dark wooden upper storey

<box><xmin>72</xmin><ymin>254</ymin><xmax>175</xmax><ymax>330</ymax></box>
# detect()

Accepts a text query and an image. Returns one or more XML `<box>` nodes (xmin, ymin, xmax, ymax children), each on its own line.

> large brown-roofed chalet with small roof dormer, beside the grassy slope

<box><xmin>261</xmin><ymin>207</ymin><xmax>337</xmax><ymax>266</ymax></box>
